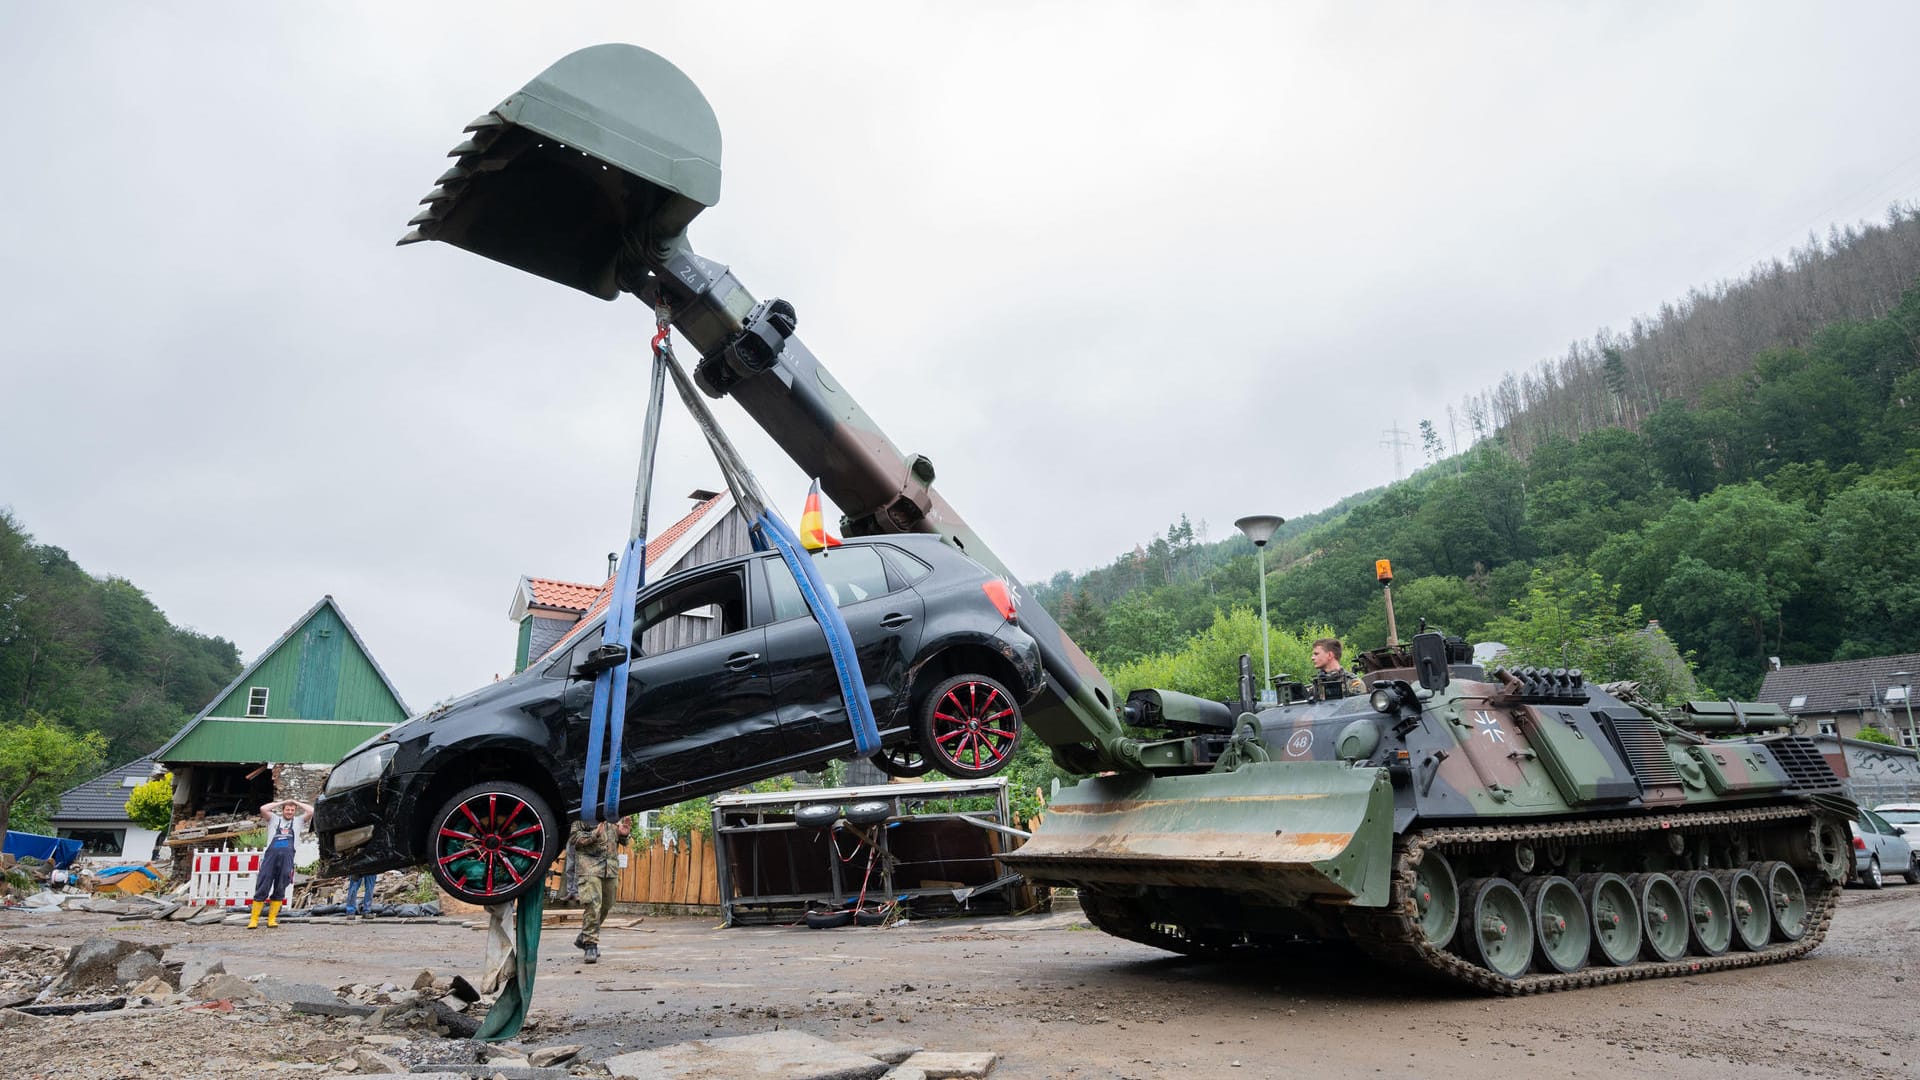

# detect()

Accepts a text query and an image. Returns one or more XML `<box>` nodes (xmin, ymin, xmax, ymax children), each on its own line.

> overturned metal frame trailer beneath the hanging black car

<box><xmin>712</xmin><ymin>776</ymin><xmax>1027</xmax><ymax>926</ymax></box>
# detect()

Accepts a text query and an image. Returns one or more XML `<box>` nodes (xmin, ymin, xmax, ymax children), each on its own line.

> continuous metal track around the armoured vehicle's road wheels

<box><xmin>1344</xmin><ymin>807</ymin><xmax>1841</xmax><ymax>995</ymax></box>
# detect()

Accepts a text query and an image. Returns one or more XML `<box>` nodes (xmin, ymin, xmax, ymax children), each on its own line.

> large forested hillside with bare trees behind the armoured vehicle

<box><xmin>1041</xmin><ymin>209</ymin><xmax>1920</xmax><ymax>696</ymax></box>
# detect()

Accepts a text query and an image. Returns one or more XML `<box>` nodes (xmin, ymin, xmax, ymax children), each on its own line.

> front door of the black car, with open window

<box><xmin>620</xmin><ymin>563</ymin><xmax>781</xmax><ymax>801</ymax></box>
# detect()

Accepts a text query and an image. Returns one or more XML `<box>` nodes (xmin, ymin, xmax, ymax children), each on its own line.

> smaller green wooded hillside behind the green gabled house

<box><xmin>0</xmin><ymin>511</ymin><xmax>240</xmax><ymax>798</ymax></box>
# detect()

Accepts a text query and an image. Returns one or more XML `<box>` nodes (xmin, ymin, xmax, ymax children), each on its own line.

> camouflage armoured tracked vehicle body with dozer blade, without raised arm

<box><xmin>1006</xmin><ymin>644</ymin><xmax>1853</xmax><ymax>994</ymax></box>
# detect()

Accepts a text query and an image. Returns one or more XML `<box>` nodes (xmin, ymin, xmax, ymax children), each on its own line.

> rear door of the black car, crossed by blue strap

<box><xmin>760</xmin><ymin>544</ymin><xmax>925</xmax><ymax>757</ymax></box>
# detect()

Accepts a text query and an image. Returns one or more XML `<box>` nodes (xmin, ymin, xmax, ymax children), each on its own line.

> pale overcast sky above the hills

<box><xmin>0</xmin><ymin>0</ymin><xmax>1920</xmax><ymax>709</ymax></box>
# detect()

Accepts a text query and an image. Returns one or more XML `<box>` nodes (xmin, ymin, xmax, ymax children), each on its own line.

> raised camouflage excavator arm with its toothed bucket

<box><xmin>401</xmin><ymin>44</ymin><xmax>1167</xmax><ymax>773</ymax></box>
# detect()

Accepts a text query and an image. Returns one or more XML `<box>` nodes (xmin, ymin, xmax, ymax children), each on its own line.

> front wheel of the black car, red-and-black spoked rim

<box><xmin>428</xmin><ymin>780</ymin><xmax>561</xmax><ymax>907</ymax></box>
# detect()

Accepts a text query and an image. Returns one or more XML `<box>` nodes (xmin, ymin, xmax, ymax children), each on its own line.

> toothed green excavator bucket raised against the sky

<box><xmin>399</xmin><ymin>44</ymin><xmax>720</xmax><ymax>300</ymax></box>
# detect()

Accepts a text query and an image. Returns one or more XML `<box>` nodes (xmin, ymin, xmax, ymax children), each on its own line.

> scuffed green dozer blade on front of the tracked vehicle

<box><xmin>1000</xmin><ymin>761</ymin><xmax>1394</xmax><ymax>907</ymax></box>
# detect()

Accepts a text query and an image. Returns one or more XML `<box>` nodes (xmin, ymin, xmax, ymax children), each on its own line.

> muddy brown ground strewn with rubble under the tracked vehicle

<box><xmin>0</xmin><ymin>886</ymin><xmax>1920</xmax><ymax>1080</ymax></box>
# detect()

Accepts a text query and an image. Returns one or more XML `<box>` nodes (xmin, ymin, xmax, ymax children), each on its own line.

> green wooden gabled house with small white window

<box><xmin>154</xmin><ymin>596</ymin><xmax>407</xmax><ymax>824</ymax></box>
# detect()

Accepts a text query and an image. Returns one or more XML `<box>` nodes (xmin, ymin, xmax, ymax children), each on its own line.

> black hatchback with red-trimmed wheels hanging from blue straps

<box><xmin>315</xmin><ymin>534</ymin><xmax>1044</xmax><ymax>903</ymax></box>
